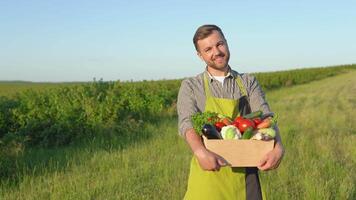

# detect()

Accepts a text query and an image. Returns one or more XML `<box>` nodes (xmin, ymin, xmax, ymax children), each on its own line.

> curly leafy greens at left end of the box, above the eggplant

<box><xmin>191</xmin><ymin>112</ymin><xmax>219</xmax><ymax>135</ymax></box>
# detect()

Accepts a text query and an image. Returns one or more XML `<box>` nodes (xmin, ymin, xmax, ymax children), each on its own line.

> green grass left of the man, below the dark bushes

<box><xmin>0</xmin><ymin>118</ymin><xmax>190</xmax><ymax>199</ymax></box>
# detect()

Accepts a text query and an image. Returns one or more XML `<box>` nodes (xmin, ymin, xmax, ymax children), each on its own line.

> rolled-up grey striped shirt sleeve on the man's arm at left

<box><xmin>177</xmin><ymin>79</ymin><xmax>198</xmax><ymax>137</ymax></box>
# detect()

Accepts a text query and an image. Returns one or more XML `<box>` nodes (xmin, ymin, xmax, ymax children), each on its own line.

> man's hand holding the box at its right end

<box><xmin>257</xmin><ymin>145</ymin><xmax>284</xmax><ymax>171</ymax></box>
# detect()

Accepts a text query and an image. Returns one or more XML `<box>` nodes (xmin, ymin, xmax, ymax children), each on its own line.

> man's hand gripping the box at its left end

<box><xmin>194</xmin><ymin>148</ymin><xmax>227</xmax><ymax>171</ymax></box>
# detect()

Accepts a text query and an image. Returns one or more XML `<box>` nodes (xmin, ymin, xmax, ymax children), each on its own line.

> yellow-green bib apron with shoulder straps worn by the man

<box><xmin>184</xmin><ymin>75</ymin><xmax>262</xmax><ymax>200</ymax></box>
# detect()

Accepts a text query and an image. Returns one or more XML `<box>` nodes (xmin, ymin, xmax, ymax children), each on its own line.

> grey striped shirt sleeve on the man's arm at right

<box><xmin>248</xmin><ymin>75</ymin><xmax>272</xmax><ymax>114</ymax></box>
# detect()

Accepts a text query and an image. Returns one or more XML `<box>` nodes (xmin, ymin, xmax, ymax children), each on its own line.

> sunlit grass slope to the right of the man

<box><xmin>262</xmin><ymin>72</ymin><xmax>356</xmax><ymax>199</ymax></box>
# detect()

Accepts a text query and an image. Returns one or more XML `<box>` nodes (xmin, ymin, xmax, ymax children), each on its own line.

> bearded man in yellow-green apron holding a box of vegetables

<box><xmin>177</xmin><ymin>25</ymin><xmax>284</xmax><ymax>200</ymax></box>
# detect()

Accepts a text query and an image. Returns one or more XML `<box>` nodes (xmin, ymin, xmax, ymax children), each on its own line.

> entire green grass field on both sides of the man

<box><xmin>0</xmin><ymin>71</ymin><xmax>356</xmax><ymax>200</ymax></box>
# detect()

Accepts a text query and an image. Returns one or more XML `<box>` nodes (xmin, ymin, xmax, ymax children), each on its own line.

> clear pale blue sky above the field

<box><xmin>0</xmin><ymin>0</ymin><xmax>356</xmax><ymax>82</ymax></box>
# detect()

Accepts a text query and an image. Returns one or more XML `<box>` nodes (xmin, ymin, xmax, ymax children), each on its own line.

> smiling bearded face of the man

<box><xmin>197</xmin><ymin>31</ymin><xmax>230</xmax><ymax>70</ymax></box>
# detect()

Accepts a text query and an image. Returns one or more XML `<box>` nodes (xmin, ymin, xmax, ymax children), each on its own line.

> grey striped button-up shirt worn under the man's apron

<box><xmin>177</xmin><ymin>69</ymin><xmax>271</xmax><ymax>137</ymax></box>
